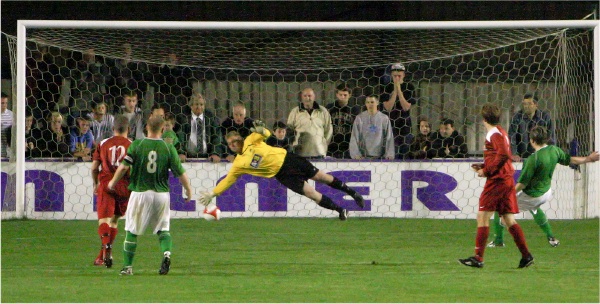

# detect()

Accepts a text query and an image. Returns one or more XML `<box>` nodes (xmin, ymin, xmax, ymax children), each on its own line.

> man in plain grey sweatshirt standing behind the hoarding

<box><xmin>350</xmin><ymin>96</ymin><xmax>395</xmax><ymax>160</ymax></box>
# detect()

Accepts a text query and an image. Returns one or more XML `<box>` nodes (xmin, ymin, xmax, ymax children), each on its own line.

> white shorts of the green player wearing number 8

<box><xmin>125</xmin><ymin>190</ymin><xmax>171</xmax><ymax>235</ymax></box>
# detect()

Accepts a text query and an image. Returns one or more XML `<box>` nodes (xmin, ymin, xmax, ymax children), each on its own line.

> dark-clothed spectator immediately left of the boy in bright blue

<box><xmin>36</xmin><ymin>112</ymin><xmax>70</xmax><ymax>157</ymax></box>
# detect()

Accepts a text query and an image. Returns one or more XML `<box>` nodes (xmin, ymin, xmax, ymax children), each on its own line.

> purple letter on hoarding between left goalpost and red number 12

<box><xmin>25</xmin><ymin>170</ymin><xmax>65</xmax><ymax>212</ymax></box>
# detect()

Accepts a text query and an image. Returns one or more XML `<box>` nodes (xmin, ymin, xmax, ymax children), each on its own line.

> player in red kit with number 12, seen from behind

<box><xmin>92</xmin><ymin>115</ymin><xmax>131</xmax><ymax>268</ymax></box>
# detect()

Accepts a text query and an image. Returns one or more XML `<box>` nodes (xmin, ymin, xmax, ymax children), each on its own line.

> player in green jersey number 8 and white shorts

<box><xmin>108</xmin><ymin>116</ymin><xmax>192</xmax><ymax>275</ymax></box>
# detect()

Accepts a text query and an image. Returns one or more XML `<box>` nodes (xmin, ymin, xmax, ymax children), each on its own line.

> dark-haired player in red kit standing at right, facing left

<box><xmin>458</xmin><ymin>103</ymin><xmax>533</xmax><ymax>268</ymax></box>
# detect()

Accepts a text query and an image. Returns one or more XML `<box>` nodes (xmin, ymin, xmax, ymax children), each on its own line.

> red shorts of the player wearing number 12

<box><xmin>96</xmin><ymin>180</ymin><xmax>131</xmax><ymax>219</ymax></box>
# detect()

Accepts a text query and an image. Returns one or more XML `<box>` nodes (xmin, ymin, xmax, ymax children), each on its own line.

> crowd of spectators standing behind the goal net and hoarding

<box><xmin>1</xmin><ymin>47</ymin><xmax>555</xmax><ymax>162</ymax></box>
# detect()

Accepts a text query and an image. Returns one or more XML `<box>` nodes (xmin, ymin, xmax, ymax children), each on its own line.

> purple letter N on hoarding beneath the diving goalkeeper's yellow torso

<box><xmin>217</xmin><ymin>175</ymin><xmax>287</xmax><ymax>212</ymax></box>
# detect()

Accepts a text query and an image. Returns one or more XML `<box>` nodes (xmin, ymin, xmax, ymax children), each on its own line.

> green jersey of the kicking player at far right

<box><xmin>518</xmin><ymin>145</ymin><xmax>571</xmax><ymax>197</ymax></box>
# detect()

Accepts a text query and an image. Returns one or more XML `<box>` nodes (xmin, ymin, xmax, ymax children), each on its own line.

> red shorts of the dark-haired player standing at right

<box><xmin>479</xmin><ymin>176</ymin><xmax>519</xmax><ymax>215</ymax></box>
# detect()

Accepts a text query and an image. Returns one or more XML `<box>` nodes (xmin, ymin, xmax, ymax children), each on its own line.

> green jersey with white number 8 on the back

<box><xmin>123</xmin><ymin>138</ymin><xmax>185</xmax><ymax>192</ymax></box>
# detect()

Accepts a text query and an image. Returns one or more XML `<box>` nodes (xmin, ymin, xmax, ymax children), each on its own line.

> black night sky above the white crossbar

<box><xmin>0</xmin><ymin>0</ymin><xmax>598</xmax><ymax>78</ymax></box>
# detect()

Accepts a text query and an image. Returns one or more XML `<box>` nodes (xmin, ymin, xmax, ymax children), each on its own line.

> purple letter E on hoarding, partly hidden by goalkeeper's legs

<box><xmin>315</xmin><ymin>171</ymin><xmax>371</xmax><ymax>211</ymax></box>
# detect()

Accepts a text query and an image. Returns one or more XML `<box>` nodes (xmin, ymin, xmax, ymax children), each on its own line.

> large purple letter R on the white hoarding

<box><xmin>401</xmin><ymin>170</ymin><xmax>460</xmax><ymax>211</ymax></box>
